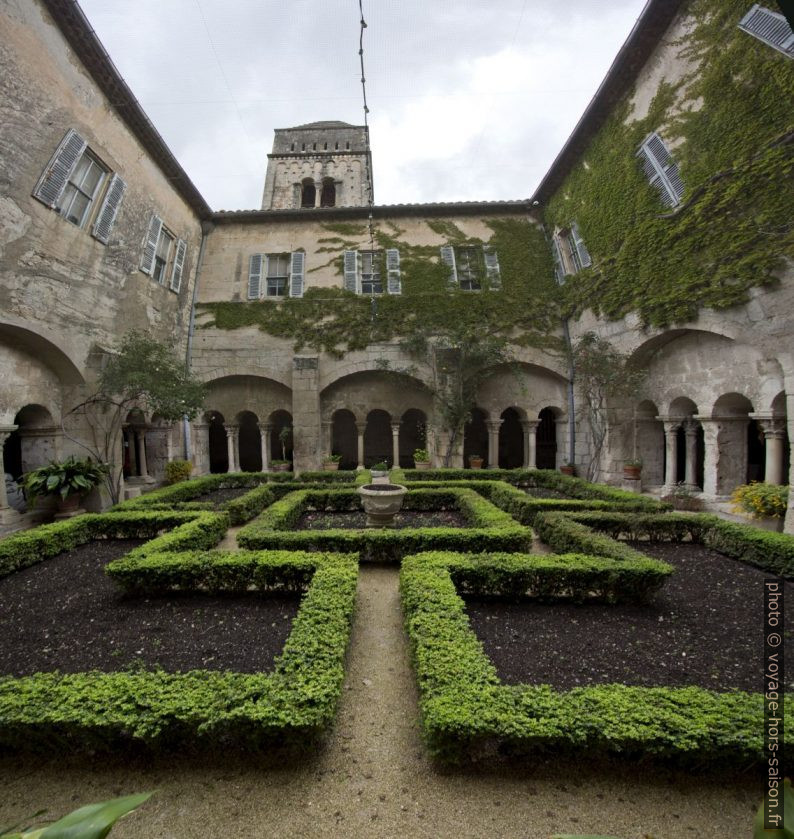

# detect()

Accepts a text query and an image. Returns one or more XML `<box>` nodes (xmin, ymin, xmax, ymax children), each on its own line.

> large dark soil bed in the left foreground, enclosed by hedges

<box><xmin>0</xmin><ymin>539</ymin><xmax>299</xmax><ymax>676</ymax></box>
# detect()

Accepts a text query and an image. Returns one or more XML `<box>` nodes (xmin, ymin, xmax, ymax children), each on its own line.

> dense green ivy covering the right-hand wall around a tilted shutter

<box><xmin>545</xmin><ymin>0</ymin><xmax>794</xmax><ymax>327</ymax></box>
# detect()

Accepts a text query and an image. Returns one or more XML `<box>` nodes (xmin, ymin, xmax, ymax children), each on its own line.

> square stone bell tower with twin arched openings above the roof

<box><xmin>262</xmin><ymin>121</ymin><xmax>371</xmax><ymax>210</ymax></box>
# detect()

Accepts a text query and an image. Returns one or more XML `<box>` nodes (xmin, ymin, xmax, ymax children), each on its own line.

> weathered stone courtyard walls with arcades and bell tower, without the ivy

<box><xmin>0</xmin><ymin>0</ymin><xmax>794</xmax><ymax>532</ymax></box>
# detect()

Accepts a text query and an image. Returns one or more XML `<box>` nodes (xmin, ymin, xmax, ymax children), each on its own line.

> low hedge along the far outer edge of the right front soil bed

<box><xmin>535</xmin><ymin>512</ymin><xmax>794</xmax><ymax>579</ymax></box>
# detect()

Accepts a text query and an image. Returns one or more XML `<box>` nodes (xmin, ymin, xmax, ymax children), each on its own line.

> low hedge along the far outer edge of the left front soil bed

<box><xmin>0</xmin><ymin>510</ymin><xmax>223</xmax><ymax>577</ymax></box>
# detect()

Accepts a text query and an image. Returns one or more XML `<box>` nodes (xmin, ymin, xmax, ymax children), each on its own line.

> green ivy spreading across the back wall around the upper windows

<box><xmin>199</xmin><ymin>218</ymin><xmax>559</xmax><ymax>357</ymax></box>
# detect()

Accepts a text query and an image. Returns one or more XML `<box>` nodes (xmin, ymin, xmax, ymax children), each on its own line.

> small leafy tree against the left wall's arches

<box><xmin>62</xmin><ymin>331</ymin><xmax>204</xmax><ymax>504</ymax></box>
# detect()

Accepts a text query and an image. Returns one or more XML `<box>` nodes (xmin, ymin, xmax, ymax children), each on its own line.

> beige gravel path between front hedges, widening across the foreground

<box><xmin>0</xmin><ymin>565</ymin><xmax>760</xmax><ymax>839</ymax></box>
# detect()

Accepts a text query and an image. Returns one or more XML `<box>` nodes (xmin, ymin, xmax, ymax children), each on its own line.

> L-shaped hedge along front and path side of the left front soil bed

<box><xmin>0</xmin><ymin>555</ymin><xmax>357</xmax><ymax>755</ymax></box>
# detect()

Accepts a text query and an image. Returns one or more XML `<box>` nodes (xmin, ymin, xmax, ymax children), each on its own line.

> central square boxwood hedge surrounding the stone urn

<box><xmin>237</xmin><ymin>487</ymin><xmax>532</xmax><ymax>562</ymax></box>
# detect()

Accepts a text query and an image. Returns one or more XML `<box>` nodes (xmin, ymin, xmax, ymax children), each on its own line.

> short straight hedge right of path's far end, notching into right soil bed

<box><xmin>408</xmin><ymin>551</ymin><xmax>673</xmax><ymax>603</ymax></box>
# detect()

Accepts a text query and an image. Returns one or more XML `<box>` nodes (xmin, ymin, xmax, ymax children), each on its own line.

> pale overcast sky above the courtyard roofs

<box><xmin>80</xmin><ymin>0</ymin><xmax>644</xmax><ymax>210</ymax></box>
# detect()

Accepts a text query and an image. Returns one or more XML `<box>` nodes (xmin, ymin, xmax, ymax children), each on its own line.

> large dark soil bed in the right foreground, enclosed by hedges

<box><xmin>467</xmin><ymin>542</ymin><xmax>794</xmax><ymax>691</ymax></box>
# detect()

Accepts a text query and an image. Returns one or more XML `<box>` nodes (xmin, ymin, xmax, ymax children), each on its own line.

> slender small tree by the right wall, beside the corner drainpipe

<box><xmin>571</xmin><ymin>332</ymin><xmax>645</xmax><ymax>481</ymax></box>
